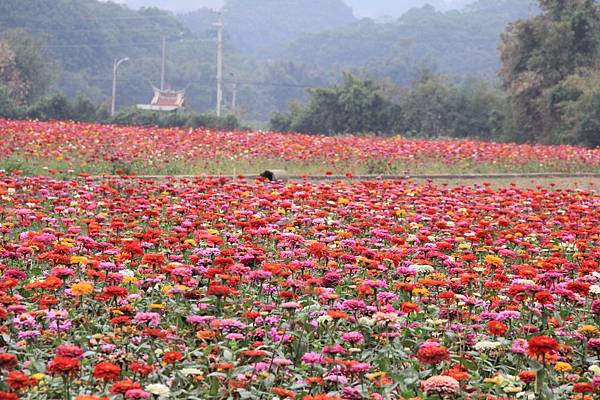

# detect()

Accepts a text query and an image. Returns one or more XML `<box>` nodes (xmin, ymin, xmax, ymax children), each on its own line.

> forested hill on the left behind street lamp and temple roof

<box><xmin>0</xmin><ymin>0</ymin><xmax>215</xmax><ymax>107</ymax></box>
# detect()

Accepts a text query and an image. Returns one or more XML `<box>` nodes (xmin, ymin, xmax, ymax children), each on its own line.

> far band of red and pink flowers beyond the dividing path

<box><xmin>0</xmin><ymin>119</ymin><xmax>600</xmax><ymax>175</ymax></box>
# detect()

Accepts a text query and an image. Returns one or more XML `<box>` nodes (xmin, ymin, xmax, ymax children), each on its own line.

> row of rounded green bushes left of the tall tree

<box><xmin>271</xmin><ymin>72</ymin><xmax>506</xmax><ymax>139</ymax></box>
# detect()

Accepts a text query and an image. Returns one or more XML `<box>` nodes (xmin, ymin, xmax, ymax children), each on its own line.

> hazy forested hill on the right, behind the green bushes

<box><xmin>285</xmin><ymin>0</ymin><xmax>537</xmax><ymax>83</ymax></box>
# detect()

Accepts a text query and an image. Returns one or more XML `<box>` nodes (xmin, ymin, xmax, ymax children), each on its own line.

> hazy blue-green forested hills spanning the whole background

<box><xmin>0</xmin><ymin>0</ymin><xmax>528</xmax><ymax>122</ymax></box>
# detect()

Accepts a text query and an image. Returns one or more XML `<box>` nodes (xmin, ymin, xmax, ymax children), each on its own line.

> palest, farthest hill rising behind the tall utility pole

<box><xmin>179</xmin><ymin>0</ymin><xmax>356</xmax><ymax>58</ymax></box>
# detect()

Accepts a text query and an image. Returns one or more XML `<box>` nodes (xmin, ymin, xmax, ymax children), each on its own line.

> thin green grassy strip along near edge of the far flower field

<box><xmin>0</xmin><ymin>154</ymin><xmax>600</xmax><ymax>176</ymax></box>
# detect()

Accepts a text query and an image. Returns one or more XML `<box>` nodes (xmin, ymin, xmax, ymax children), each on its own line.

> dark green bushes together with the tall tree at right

<box><xmin>271</xmin><ymin>0</ymin><xmax>600</xmax><ymax>147</ymax></box>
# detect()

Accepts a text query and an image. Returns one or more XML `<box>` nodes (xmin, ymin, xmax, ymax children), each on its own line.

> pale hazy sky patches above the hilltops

<box><xmin>118</xmin><ymin>0</ymin><xmax>474</xmax><ymax>18</ymax></box>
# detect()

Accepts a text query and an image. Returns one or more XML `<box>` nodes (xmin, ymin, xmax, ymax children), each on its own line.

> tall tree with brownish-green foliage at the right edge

<box><xmin>500</xmin><ymin>0</ymin><xmax>600</xmax><ymax>142</ymax></box>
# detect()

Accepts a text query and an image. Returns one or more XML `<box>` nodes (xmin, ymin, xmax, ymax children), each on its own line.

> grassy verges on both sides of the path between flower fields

<box><xmin>0</xmin><ymin>156</ymin><xmax>600</xmax><ymax>190</ymax></box>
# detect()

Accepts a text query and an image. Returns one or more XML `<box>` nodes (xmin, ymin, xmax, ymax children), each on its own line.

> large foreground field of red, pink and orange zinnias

<box><xmin>0</xmin><ymin>173</ymin><xmax>600</xmax><ymax>400</ymax></box>
